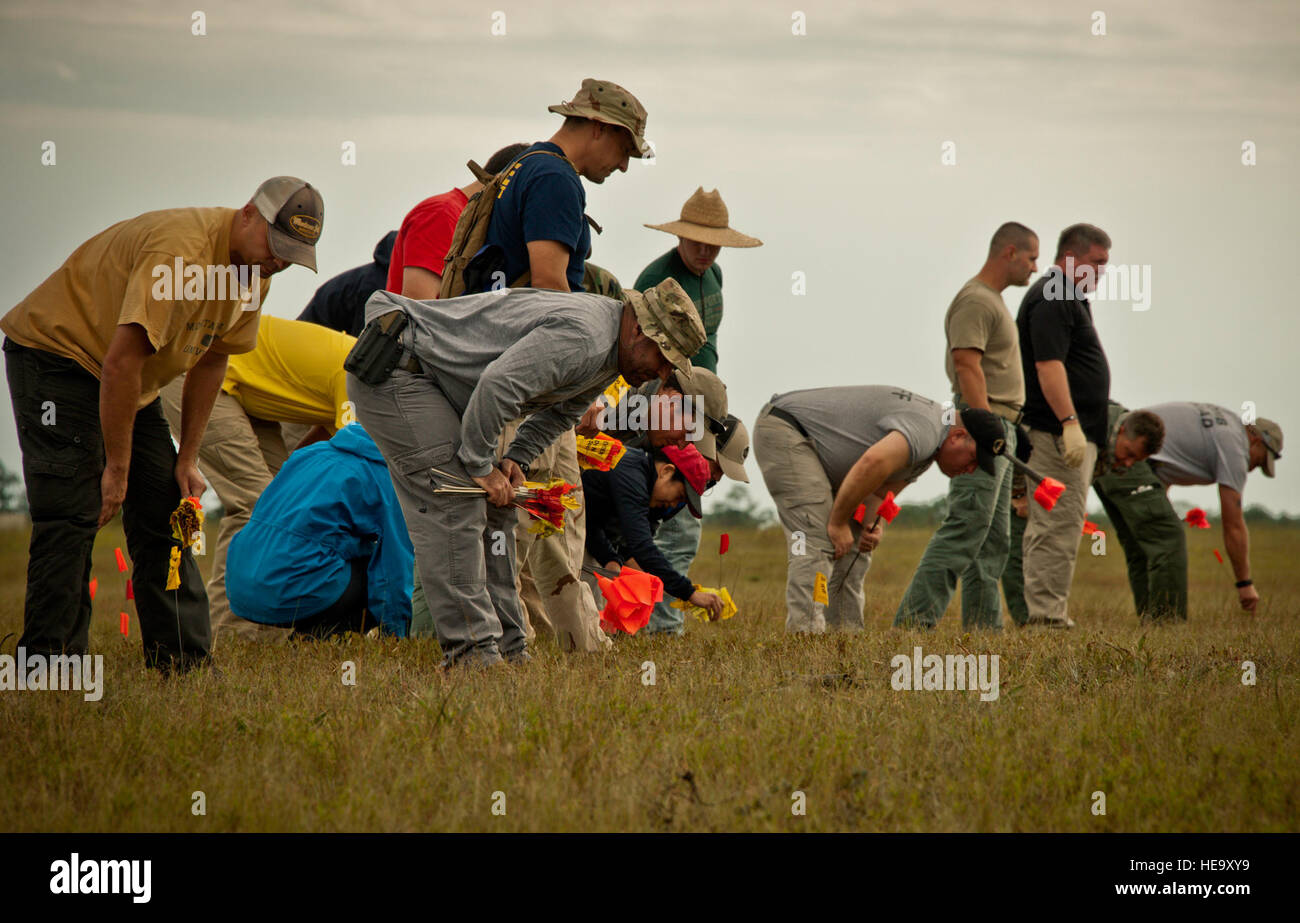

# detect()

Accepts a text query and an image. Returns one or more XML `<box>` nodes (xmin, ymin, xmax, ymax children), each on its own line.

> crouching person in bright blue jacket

<box><xmin>226</xmin><ymin>424</ymin><xmax>415</xmax><ymax>637</ymax></box>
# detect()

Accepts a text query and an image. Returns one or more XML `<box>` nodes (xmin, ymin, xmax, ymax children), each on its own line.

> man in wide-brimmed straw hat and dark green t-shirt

<box><xmin>634</xmin><ymin>186</ymin><xmax>763</xmax><ymax>634</ymax></box>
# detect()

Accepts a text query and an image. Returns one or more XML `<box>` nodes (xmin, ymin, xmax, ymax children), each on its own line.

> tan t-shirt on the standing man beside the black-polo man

<box><xmin>944</xmin><ymin>278</ymin><xmax>1024</xmax><ymax>412</ymax></box>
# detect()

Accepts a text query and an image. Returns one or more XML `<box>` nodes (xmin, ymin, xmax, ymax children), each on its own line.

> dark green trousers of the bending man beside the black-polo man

<box><xmin>1092</xmin><ymin>462</ymin><xmax>1187</xmax><ymax>620</ymax></box>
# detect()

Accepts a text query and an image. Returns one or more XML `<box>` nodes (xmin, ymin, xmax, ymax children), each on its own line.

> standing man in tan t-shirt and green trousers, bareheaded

<box><xmin>894</xmin><ymin>221</ymin><xmax>1039</xmax><ymax>629</ymax></box>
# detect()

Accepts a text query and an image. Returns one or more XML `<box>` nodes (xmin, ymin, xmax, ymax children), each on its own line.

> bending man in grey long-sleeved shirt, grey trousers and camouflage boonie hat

<box><xmin>346</xmin><ymin>280</ymin><xmax>705</xmax><ymax>667</ymax></box>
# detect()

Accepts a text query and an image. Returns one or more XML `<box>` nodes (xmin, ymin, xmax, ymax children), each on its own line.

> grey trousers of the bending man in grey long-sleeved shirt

<box><xmin>347</xmin><ymin>369</ymin><xmax>527</xmax><ymax>666</ymax></box>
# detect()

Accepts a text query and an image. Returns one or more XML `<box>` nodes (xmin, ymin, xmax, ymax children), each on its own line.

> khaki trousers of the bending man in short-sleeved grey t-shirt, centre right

<box><xmin>754</xmin><ymin>407</ymin><xmax>871</xmax><ymax>634</ymax></box>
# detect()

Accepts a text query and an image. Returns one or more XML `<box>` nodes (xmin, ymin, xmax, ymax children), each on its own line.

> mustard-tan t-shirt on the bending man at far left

<box><xmin>0</xmin><ymin>208</ymin><xmax>270</xmax><ymax>407</ymax></box>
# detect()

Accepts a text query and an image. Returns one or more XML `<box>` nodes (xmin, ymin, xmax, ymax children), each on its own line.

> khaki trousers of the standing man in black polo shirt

<box><xmin>1024</xmin><ymin>429</ymin><xmax>1097</xmax><ymax>623</ymax></box>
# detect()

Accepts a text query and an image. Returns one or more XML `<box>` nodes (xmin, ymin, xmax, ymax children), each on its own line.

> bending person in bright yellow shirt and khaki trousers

<box><xmin>163</xmin><ymin>315</ymin><xmax>356</xmax><ymax>641</ymax></box>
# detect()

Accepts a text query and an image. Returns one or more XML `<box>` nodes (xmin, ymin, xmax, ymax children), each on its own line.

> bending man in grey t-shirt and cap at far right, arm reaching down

<box><xmin>1144</xmin><ymin>400</ymin><xmax>1282</xmax><ymax>612</ymax></box>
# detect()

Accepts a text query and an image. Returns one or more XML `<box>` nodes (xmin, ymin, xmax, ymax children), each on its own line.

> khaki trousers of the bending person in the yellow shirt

<box><xmin>161</xmin><ymin>376</ymin><xmax>289</xmax><ymax>646</ymax></box>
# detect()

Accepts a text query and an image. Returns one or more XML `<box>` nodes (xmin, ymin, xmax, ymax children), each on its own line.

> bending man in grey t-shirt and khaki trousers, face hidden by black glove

<box><xmin>754</xmin><ymin>385</ymin><xmax>1002</xmax><ymax>633</ymax></box>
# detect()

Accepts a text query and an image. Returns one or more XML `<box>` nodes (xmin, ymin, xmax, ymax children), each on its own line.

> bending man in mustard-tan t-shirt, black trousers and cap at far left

<box><xmin>0</xmin><ymin>177</ymin><xmax>324</xmax><ymax>672</ymax></box>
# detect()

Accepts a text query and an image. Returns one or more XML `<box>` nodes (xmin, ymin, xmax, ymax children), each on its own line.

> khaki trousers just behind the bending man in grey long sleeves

<box><xmin>502</xmin><ymin>426</ymin><xmax>612</xmax><ymax>653</ymax></box>
